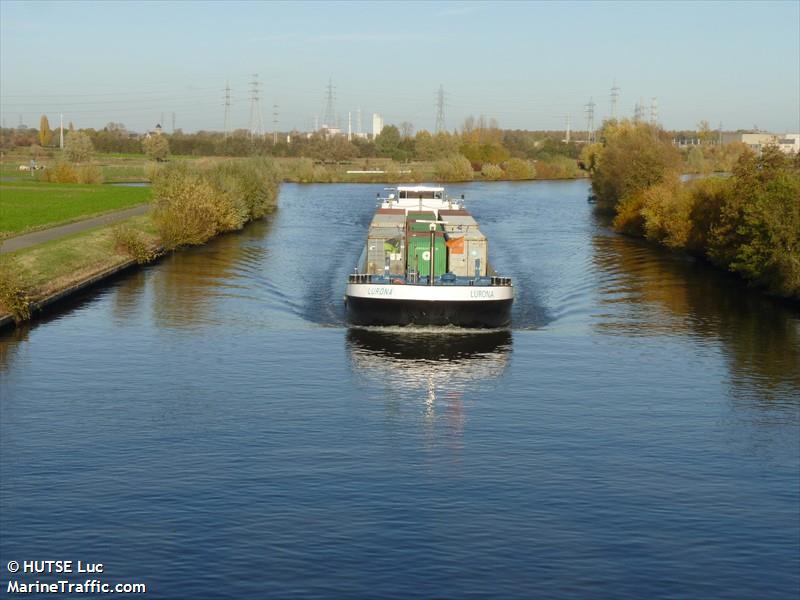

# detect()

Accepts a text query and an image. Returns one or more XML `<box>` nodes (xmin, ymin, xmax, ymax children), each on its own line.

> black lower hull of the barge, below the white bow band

<box><xmin>345</xmin><ymin>296</ymin><xmax>513</xmax><ymax>328</ymax></box>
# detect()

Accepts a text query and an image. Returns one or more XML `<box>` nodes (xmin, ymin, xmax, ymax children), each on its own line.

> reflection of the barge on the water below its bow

<box><xmin>347</xmin><ymin>328</ymin><xmax>512</xmax><ymax>436</ymax></box>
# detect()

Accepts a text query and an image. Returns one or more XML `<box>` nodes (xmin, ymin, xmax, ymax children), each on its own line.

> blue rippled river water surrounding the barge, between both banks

<box><xmin>0</xmin><ymin>181</ymin><xmax>800</xmax><ymax>599</ymax></box>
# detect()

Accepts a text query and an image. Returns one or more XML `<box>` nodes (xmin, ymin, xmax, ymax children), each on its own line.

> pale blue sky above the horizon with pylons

<box><xmin>0</xmin><ymin>0</ymin><xmax>800</xmax><ymax>131</ymax></box>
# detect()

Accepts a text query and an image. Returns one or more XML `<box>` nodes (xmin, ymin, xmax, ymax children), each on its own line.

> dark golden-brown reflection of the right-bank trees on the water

<box><xmin>592</xmin><ymin>223</ymin><xmax>800</xmax><ymax>396</ymax></box>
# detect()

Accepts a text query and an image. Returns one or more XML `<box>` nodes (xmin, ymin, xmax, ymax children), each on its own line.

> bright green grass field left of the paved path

<box><xmin>0</xmin><ymin>179</ymin><xmax>152</xmax><ymax>237</ymax></box>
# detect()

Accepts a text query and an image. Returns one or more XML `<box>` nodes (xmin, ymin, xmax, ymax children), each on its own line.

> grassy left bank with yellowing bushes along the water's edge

<box><xmin>0</xmin><ymin>161</ymin><xmax>278</xmax><ymax>326</ymax></box>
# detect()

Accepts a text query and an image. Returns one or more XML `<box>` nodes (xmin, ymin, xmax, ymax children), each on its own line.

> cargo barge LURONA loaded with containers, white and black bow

<box><xmin>345</xmin><ymin>186</ymin><xmax>514</xmax><ymax>328</ymax></box>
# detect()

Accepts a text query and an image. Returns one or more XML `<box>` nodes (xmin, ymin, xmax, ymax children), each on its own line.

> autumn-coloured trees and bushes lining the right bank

<box><xmin>581</xmin><ymin>121</ymin><xmax>800</xmax><ymax>300</ymax></box>
